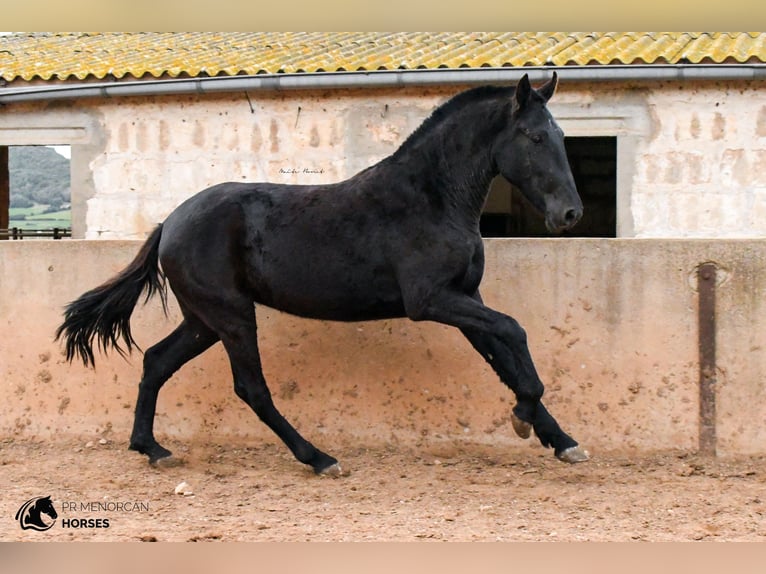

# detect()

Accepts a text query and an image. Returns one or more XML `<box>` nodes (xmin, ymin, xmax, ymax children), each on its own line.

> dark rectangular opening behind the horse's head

<box><xmin>481</xmin><ymin>137</ymin><xmax>617</xmax><ymax>237</ymax></box>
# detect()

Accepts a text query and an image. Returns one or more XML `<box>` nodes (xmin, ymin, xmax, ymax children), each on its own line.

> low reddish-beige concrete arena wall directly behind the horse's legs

<box><xmin>0</xmin><ymin>239</ymin><xmax>766</xmax><ymax>455</ymax></box>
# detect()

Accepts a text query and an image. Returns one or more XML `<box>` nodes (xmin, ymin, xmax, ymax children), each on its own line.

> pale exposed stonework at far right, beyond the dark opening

<box><xmin>632</xmin><ymin>83</ymin><xmax>766</xmax><ymax>237</ymax></box>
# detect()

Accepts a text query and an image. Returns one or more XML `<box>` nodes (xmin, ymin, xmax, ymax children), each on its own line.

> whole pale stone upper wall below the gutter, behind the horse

<box><xmin>0</xmin><ymin>82</ymin><xmax>766</xmax><ymax>239</ymax></box>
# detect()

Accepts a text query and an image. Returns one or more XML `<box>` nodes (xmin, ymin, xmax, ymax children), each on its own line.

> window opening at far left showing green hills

<box><xmin>0</xmin><ymin>145</ymin><xmax>72</xmax><ymax>243</ymax></box>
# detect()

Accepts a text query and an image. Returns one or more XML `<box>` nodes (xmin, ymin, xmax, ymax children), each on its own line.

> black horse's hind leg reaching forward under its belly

<box><xmin>200</xmin><ymin>299</ymin><xmax>340</xmax><ymax>476</ymax></box>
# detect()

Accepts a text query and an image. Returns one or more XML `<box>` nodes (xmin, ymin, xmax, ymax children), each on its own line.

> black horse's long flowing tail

<box><xmin>56</xmin><ymin>224</ymin><xmax>167</xmax><ymax>367</ymax></box>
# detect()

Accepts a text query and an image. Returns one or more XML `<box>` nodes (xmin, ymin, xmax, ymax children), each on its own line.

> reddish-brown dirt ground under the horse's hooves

<box><xmin>0</xmin><ymin>439</ymin><xmax>766</xmax><ymax>542</ymax></box>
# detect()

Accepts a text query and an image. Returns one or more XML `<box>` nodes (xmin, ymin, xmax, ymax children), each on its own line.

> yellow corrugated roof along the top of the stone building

<box><xmin>0</xmin><ymin>32</ymin><xmax>766</xmax><ymax>81</ymax></box>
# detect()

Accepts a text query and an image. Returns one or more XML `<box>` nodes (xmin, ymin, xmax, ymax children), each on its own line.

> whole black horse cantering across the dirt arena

<box><xmin>56</xmin><ymin>73</ymin><xmax>588</xmax><ymax>474</ymax></box>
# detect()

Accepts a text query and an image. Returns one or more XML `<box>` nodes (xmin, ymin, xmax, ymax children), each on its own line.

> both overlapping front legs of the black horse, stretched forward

<box><xmin>408</xmin><ymin>291</ymin><xmax>588</xmax><ymax>462</ymax></box>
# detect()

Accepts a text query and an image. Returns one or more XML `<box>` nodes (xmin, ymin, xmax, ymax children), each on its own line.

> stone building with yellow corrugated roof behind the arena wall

<box><xmin>0</xmin><ymin>32</ymin><xmax>766</xmax><ymax>239</ymax></box>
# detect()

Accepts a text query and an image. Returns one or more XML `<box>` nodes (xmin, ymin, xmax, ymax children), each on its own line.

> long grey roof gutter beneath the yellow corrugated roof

<box><xmin>0</xmin><ymin>63</ymin><xmax>766</xmax><ymax>104</ymax></box>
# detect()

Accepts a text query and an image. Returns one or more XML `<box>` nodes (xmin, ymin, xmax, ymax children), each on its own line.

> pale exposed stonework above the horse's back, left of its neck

<box><xmin>85</xmin><ymin>91</ymin><xmax>443</xmax><ymax>238</ymax></box>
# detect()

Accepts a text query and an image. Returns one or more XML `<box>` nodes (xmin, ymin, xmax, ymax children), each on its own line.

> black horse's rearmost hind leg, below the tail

<box><xmin>130</xmin><ymin>317</ymin><xmax>218</xmax><ymax>464</ymax></box>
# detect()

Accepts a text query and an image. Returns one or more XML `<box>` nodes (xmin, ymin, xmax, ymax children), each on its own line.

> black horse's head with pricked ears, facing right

<box><xmin>492</xmin><ymin>72</ymin><xmax>582</xmax><ymax>233</ymax></box>
